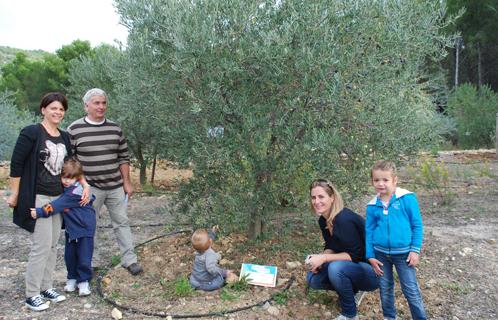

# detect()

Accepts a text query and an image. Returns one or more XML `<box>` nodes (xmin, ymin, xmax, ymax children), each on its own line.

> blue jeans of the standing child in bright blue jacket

<box><xmin>375</xmin><ymin>251</ymin><xmax>426</xmax><ymax>320</ymax></box>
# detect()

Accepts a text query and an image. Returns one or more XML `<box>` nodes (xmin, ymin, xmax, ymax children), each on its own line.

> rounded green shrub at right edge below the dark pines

<box><xmin>447</xmin><ymin>84</ymin><xmax>498</xmax><ymax>149</ymax></box>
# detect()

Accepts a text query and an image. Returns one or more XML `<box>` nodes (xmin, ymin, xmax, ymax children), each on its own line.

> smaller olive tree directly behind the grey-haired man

<box><xmin>66</xmin><ymin>40</ymin><xmax>184</xmax><ymax>184</ymax></box>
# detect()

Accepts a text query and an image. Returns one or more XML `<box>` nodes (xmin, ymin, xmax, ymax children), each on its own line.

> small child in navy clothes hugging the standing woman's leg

<box><xmin>31</xmin><ymin>159</ymin><xmax>96</xmax><ymax>296</ymax></box>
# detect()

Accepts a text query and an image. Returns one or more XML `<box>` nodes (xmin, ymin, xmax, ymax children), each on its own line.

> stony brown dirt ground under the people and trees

<box><xmin>0</xmin><ymin>150</ymin><xmax>498</xmax><ymax>320</ymax></box>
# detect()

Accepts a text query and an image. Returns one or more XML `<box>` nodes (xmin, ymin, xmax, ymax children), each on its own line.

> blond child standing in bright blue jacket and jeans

<box><xmin>365</xmin><ymin>160</ymin><xmax>426</xmax><ymax>320</ymax></box>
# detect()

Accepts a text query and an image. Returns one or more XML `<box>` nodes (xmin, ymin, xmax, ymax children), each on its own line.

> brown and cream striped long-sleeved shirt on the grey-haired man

<box><xmin>67</xmin><ymin>118</ymin><xmax>130</xmax><ymax>190</ymax></box>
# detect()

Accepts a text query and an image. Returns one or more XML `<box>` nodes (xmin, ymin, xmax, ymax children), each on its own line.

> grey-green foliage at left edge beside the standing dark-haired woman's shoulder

<box><xmin>0</xmin><ymin>91</ymin><xmax>35</xmax><ymax>160</ymax></box>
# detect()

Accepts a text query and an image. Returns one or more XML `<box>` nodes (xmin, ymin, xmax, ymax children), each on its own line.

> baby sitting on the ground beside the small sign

<box><xmin>189</xmin><ymin>229</ymin><xmax>233</xmax><ymax>291</ymax></box>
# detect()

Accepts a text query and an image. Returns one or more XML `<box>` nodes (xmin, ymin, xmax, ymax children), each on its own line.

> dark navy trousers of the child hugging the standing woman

<box><xmin>64</xmin><ymin>233</ymin><xmax>93</xmax><ymax>283</ymax></box>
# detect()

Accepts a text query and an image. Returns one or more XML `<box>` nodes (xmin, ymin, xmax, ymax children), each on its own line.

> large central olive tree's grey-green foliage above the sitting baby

<box><xmin>116</xmin><ymin>0</ymin><xmax>456</xmax><ymax>237</ymax></box>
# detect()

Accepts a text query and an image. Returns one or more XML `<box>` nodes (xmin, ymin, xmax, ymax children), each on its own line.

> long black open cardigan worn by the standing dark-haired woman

<box><xmin>10</xmin><ymin>123</ymin><xmax>71</xmax><ymax>232</ymax></box>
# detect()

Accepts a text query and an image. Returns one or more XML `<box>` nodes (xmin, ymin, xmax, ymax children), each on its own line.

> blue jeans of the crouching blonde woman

<box><xmin>306</xmin><ymin>261</ymin><xmax>379</xmax><ymax>318</ymax></box>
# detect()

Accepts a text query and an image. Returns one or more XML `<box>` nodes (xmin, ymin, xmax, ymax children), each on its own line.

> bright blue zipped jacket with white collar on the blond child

<box><xmin>365</xmin><ymin>188</ymin><xmax>423</xmax><ymax>259</ymax></box>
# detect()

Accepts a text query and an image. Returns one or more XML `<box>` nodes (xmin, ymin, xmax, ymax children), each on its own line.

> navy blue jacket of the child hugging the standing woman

<box><xmin>36</xmin><ymin>182</ymin><xmax>97</xmax><ymax>240</ymax></box>
